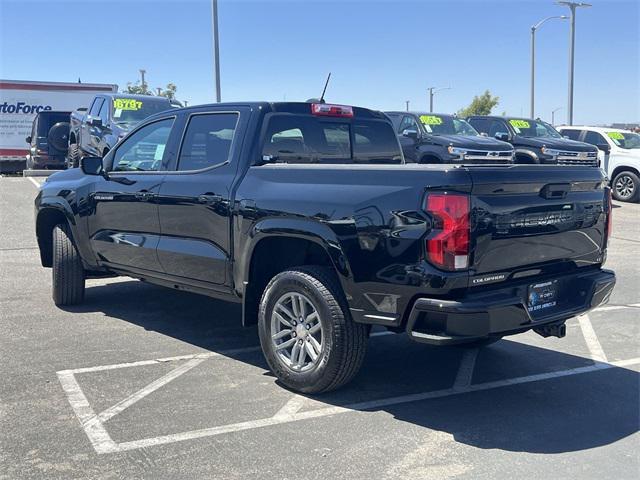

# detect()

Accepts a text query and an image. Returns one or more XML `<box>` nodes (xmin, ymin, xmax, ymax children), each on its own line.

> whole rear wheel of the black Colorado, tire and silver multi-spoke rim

<box><xmin>258</xmin><ymin>266</ymin><xmax>368</xmax><ymax>393</ymax></box>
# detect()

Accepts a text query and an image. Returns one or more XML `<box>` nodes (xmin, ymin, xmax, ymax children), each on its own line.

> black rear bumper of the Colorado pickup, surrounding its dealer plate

<box><xmin>406</xmin><ymin>270</ymin><xmax>616</xmax><ymax>345</ymax></box>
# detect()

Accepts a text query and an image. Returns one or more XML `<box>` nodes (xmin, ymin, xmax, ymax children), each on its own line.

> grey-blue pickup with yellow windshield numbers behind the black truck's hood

<box><xmin>69</xmin><ymin>93</ymin><xmax>173</xmax><ymax>167</ymax></box>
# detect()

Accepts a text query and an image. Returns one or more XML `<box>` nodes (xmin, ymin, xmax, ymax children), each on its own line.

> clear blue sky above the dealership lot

<box><xmin>0</xmin><ymin>0</ymin><xmax>640</xmax><ymax>124</ymax></box>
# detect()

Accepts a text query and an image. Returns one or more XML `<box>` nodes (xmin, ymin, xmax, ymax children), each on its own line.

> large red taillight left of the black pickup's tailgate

<box><xmin>425</xmin><ymin>193</ymin><xmax>469</xmax><ymax>270</ymax></box>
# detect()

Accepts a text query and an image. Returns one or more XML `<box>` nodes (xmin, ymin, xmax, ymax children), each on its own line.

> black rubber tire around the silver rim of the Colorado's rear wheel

<box><xmin>258</xmin><ymin>266</ymin><xmax>368</xmax><ymax>393</ymax></box>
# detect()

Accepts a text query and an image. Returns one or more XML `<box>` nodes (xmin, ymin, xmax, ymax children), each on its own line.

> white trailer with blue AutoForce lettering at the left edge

<box><xmin>0</xmin><ymin>80</ymin><xmax>118</xmax><ymax>172</ymax></box>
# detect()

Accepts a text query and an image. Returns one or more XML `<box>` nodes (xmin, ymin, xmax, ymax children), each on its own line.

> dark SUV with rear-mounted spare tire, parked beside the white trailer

<box><xmin>25</xmin><ymin>110</ymin><xmax>71</xmax><ymax>169</ymax></box>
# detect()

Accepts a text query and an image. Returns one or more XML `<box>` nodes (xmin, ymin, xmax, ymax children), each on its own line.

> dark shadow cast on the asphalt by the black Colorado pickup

<box><xmin>68</xmin><ymin>281</ymin><xmax>640</xmax><ymax>453</ymax></box>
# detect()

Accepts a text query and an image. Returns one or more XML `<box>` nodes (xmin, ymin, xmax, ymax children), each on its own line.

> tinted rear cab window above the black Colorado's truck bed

<box><xmin>261</xmin><ymin>104</ymin><xmax>403</xmax><ymax>164</ymax></box>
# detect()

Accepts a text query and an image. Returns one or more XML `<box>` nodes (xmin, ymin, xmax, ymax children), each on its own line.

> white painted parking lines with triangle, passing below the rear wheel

<box><xmin>57</xmin><ymin>342</ymin><xmax>640</xmax><ymax>454</ymax></box>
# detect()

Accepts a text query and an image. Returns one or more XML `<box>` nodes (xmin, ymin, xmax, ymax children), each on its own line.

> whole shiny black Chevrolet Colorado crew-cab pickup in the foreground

<box><xmin>35</xmin><ymin>103</ymin><xmax>615</xmax><ymax>392</ymax></box>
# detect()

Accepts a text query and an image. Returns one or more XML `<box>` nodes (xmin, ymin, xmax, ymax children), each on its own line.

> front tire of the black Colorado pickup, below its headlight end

<box><xmin>52</xmin><ymin>224</ymin><xmax>84</xmax><ymax>306</ymax></box>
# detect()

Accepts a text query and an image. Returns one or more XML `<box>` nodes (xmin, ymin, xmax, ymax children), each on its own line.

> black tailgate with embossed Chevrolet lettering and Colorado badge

<box><xmin>468</xmin><ymin>165</ymin><xmax>607</xmax><ymax>286</ymax></box>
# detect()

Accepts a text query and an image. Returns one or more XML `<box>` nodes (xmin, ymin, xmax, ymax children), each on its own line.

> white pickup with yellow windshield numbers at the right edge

<box><xmin>558</xmin><ymin>126</ymin><xmax>640</xmax><ymax>202</ymax></box>
